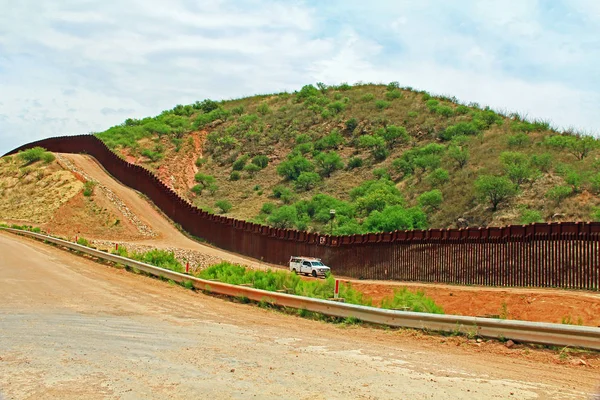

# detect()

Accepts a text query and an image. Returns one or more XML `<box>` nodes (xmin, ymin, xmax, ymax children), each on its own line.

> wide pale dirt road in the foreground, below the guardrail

<box><xmin>0</xmin><ymin>233</ymin><xmax>598</xmax><ymax>399</ymax></box>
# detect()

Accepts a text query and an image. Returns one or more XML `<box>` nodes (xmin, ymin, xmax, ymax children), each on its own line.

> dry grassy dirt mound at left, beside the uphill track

<box><xmin>0</xmin><ymin>156</ymin><xmax>143</xmax><ymax>239</ymax></box>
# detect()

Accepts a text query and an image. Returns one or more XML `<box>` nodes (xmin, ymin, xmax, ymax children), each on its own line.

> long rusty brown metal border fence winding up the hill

<box><xmin>8</xmin><ymin>135</ymin><xmax>600</xmax><ymax>290</ymax></box>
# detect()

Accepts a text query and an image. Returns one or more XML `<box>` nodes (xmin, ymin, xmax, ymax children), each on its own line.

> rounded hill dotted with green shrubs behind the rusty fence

<box><xmin>97</xmin><ymin>82</ymin><xmax>600</xmax><ymax>234</ymax></box>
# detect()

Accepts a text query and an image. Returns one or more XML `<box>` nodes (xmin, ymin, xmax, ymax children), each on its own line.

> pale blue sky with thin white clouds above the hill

<box><xmin>0</xmin><ymin>0</ymin><xmax>600</xmax><ymax>154</ymax></box>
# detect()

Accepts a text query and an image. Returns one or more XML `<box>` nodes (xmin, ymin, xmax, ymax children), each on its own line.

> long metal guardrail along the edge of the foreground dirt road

<box><xmin>2</xmin><ymin>228</ymin><xmax>600</xmax><ymax>350</ymax></box>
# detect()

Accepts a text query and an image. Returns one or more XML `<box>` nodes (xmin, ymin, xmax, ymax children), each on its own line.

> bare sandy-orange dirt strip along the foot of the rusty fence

<box><xmin>52</xmin><ymin>154</ymin><xmax>600</xmax><ymax>326</ymax></box>
